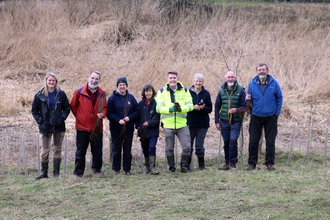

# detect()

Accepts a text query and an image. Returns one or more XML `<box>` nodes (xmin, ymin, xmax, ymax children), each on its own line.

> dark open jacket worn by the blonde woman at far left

<box><xmin>32</xmin><ymin>88</ymin><xmax>70</xmax><ymax>136</ymax></box>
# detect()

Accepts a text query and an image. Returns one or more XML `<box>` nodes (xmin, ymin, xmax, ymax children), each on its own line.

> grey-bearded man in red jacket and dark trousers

<box><xmin>71</xmin><ymin>70</ymin><xmax>107</xmax><ymax>177</ymax></box>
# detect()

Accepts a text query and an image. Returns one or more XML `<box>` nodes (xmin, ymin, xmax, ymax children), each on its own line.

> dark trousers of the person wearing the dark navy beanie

<box><xmin>111</xmin><ymin>131</ymin><xmax>133</xmax><ymax>172</ymax></box>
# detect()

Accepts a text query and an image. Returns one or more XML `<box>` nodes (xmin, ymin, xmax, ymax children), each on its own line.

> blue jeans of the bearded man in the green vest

<box><xmin>220</xmin><ymin>120</ymin><xmax>242</xmax><ymax>163</ymax></box>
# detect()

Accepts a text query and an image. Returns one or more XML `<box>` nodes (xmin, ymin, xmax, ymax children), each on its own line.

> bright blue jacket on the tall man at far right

<box><xmin>246</xmin><ymin>75</ymin><xmax>283</xmax><ymax>117</ymax></box>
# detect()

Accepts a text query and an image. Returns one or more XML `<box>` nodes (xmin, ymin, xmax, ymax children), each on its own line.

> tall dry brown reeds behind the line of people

<box><xmin>0</xmin><ymin>0</ymin><xmax>330</xmax><ymax>167</ymax></box>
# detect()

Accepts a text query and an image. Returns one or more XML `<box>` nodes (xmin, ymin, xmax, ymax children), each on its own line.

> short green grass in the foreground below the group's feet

<box><xmin>0</xmin><ymin>152</ymin><xmax>330</xmax><ymax>219</ymax></box>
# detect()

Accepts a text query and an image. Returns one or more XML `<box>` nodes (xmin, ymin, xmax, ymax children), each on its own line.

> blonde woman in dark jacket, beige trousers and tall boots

<box><xmin>32</xmin><ymin>72</ymin><xmax>70</xmax><ymax>180</ymax></box>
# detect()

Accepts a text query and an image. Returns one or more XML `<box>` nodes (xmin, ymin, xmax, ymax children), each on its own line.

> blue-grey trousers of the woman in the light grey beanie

<box><xmin>189</xmin><ymin>127</ymin><xmax>208</xmax><ymax>157</ymax></box>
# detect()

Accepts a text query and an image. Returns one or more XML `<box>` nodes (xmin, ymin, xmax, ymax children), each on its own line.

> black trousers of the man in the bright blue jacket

<box><xmin>248</xmin><ymin>115</ymin><xmax>277</xmax><ymax>166</ymax></box>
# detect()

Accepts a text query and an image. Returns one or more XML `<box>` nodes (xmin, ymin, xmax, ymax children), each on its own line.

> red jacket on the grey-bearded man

<box><xmin>70</xmin><ymin>83</ymin><xmax>107</xmax><ymax>132</ymax></box>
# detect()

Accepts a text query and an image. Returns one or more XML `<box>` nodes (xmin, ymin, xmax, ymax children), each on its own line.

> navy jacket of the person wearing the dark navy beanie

<box><xmin>107</xmin><ymin>90</ymin><xmax>139</xmax><ymax>132</ymax></box>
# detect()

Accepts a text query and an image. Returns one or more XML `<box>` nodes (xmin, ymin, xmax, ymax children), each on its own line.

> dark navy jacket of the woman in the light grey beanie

<box><xmin>187</xmin><ymin>86</ymin><xmax>212</xmax><ymax>128</ymax></box>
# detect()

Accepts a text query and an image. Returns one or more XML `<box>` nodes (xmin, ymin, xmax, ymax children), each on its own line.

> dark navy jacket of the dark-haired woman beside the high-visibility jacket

<box><xmin>136</xmin><ymin>98</ymin><xmax>160</xmax><ymax>138</ymax></box>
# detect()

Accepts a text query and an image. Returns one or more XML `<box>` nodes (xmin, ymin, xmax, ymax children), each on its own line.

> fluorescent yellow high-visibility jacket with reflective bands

<box><xmin>156</xmin><ymin>81</ymin><xmax>194</xmax><ymax>129</ymax></box>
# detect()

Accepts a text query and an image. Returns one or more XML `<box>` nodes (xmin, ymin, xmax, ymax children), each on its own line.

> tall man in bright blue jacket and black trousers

<box><xmin>246</xmin><ymin>63</ymin><xmax>283</xmax><ymax>171</ymax></box>
